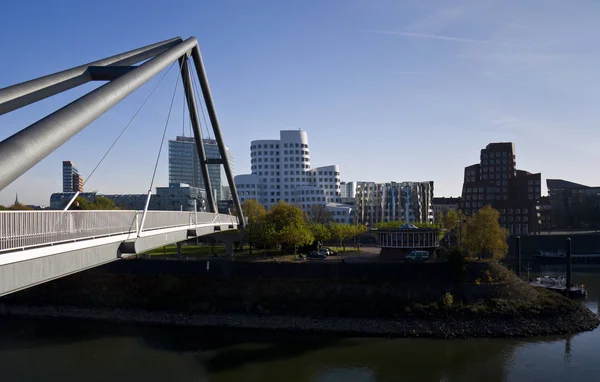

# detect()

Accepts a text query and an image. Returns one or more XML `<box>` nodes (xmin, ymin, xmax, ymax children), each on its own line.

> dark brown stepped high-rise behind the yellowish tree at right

<box><xmin>461</xmin><ymin>142</ymin><xmax>541</xmax><ymax>235</ymax></box>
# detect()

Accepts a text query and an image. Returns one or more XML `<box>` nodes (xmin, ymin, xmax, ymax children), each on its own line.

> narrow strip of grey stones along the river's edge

<box><xmin>0</xmin><ymin>304</ymin><xmax>598</xmax><ymax>339</ymax></box>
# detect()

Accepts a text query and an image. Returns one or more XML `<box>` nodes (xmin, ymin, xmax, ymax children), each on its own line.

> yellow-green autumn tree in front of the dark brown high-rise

<box><xmin>462</xmin><ymin>206</ymin><xmax>508</xmax><ymax>259</ymax></box>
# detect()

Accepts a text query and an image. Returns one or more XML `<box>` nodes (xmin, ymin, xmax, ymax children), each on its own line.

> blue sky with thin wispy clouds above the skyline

<box><xmin>0</xmin><ymin>0</ymin><xmax>600</xmax><ymax>205</ymax></box>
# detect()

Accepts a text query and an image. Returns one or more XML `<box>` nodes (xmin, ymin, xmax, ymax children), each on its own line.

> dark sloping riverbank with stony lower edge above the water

<box><xmin>0</xmin><ymin>263</ymin><xmax>598</xmax><ymax>338</ymax></box>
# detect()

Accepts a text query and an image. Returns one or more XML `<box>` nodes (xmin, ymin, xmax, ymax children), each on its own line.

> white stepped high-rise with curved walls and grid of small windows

<box><xmin>235</xmin><ymin>130</ymin><xmax>350</xmax><ymax>214</ymax></box>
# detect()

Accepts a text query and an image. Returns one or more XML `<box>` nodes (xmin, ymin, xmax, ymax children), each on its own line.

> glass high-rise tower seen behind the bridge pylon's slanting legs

<box><xmin>169</xmin><ymin>136</ymin><xmax>234</xmax><ymax>202</ymax></box>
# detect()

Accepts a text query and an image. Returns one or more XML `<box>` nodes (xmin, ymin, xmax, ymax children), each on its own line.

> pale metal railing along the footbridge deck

<box><xmin>0</xmin><ymin>211</ymin><xmax>237</xmax><ymax>252</ymax></box>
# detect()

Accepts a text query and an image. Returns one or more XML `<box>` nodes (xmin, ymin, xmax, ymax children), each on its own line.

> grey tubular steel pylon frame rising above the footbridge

<box><xmin>0</xmin><ymin>37</ymin><xmax>244</xmax><ymax>227</ymax></box>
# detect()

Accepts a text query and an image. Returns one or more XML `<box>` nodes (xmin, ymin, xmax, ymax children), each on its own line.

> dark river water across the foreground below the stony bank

<box><xmin>0</xmin><ymin>273</ymin><xmax>600</xmax><ymax>382</ymax></box>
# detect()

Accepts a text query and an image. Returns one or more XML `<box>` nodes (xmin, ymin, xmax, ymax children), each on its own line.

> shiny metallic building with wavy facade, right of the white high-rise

<box><xmin>354</xmin><ymin>181</ymin><xmax>433</xmax><ymax>227</ymax></box>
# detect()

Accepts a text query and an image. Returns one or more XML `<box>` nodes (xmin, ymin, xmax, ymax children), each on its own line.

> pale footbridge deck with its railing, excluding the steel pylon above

<box><xmin>0</xmin><ymin>211</ymin><xmax>239</xmax><ymax>296</ymax></box>
